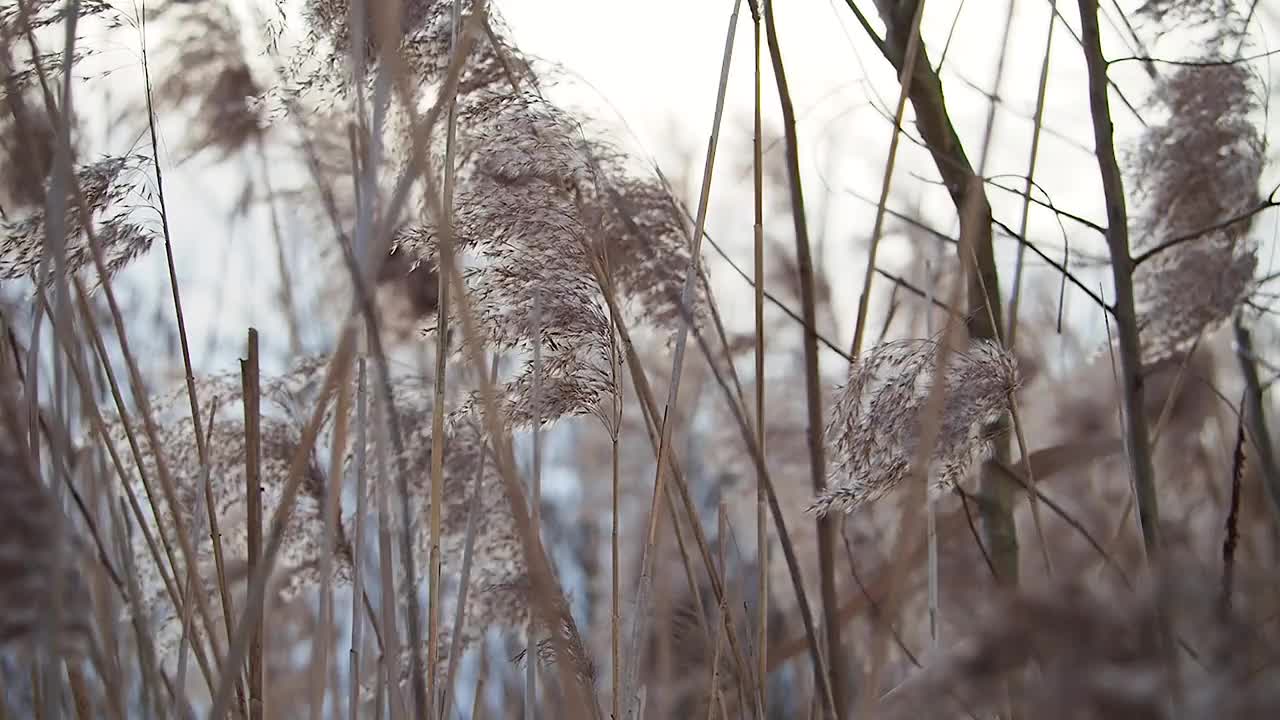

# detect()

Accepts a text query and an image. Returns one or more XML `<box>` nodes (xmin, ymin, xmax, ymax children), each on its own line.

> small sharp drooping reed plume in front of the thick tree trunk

<box><xmin>808</xmin><ymin>340</ymin><xmax>1019</xmax><ymax>515</ymax></box>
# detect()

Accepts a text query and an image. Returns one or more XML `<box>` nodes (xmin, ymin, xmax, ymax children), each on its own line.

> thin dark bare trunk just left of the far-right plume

<box><xmin>1079</xmin><ymin>0</ymin><xmax>1161</xmax><ymax>562</ymax></box>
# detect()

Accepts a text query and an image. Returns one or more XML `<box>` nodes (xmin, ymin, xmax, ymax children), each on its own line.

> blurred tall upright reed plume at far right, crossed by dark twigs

<box><xmin>1130</xmin><ymin>64</ymin><xmax>1265</xmax><ymax>364</ymax></box>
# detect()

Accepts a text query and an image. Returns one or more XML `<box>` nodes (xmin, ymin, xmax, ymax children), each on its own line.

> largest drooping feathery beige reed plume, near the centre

<box><xmin>397</xmin><ymin>94</ymin><xmax>703</xmax><ymax>427</ymax></box>
